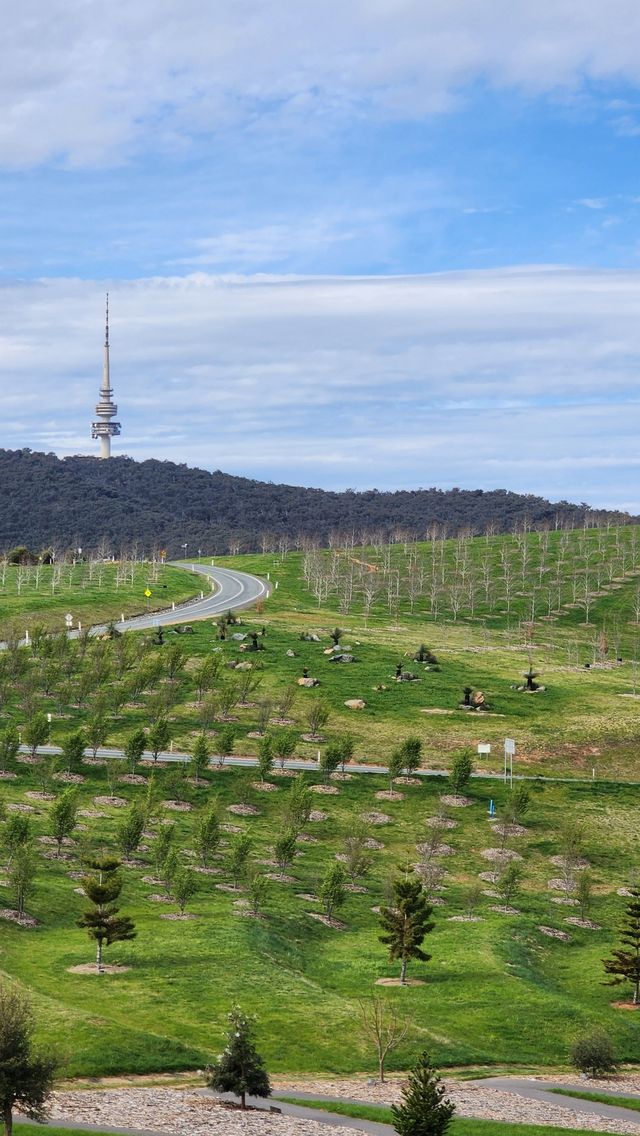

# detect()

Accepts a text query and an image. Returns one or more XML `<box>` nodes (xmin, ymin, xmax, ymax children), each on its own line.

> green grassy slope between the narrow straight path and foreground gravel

<box><xmin>0</xmin><ymin>763</ymin><xmax>640</xmax><ymax>1075</ymax></box>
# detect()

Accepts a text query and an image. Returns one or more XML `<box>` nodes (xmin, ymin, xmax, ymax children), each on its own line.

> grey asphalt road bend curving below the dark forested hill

<box><xmin>91</xmin><ymin>560</ymin><xmax>269</xmax><ymax>635</ymax></box>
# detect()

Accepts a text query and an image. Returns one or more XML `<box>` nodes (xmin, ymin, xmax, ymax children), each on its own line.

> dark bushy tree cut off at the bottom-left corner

<box><xmin>0</xmin><ymin>985</ymin><xmax>57</xmax><ymax>1136</ymax></box>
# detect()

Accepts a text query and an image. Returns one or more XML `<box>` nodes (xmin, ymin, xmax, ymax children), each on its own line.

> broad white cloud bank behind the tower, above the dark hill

<box><xmin>0</xmin><ymin>267</ymin><xmax>640</xmax><ymax>511</ymax></box>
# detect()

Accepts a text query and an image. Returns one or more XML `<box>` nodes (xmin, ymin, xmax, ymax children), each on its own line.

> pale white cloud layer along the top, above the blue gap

<box><xmin>0</xmin><ymin>0</ymin><xmax>640</xmax><ymax>167</ymax></box>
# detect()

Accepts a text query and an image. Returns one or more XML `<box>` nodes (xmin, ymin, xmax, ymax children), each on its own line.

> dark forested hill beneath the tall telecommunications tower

<box><xmin>0</xmin><ymin>450</ymin><xmax>630</xmax><ymax>556</ymax></box>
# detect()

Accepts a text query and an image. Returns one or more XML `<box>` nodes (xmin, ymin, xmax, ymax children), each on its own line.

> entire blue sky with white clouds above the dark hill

<box><xmin>0</xmin><ymin>0</ymin><xmax>640</xmax><ymax>512</ymax></box>
